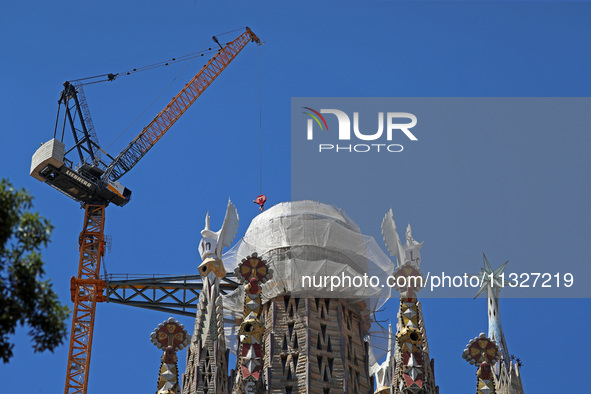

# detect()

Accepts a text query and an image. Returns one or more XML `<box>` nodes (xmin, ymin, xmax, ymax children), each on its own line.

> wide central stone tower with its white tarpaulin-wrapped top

<box><xmin>225</xmin><ymin>201</ymin><xmax>393</xmax><ymax>394</ymax></box>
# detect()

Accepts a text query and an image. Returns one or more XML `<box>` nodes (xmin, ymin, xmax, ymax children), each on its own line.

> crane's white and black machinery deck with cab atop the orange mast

<box><xmin>30</xmin><ymin>138</ymin><xmax>131</xmax><ymax>207</ymax></box>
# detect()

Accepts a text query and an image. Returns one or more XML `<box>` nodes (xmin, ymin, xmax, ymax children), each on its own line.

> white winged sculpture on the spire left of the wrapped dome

<box><xmin>199</xmin><ymin>200</ymin><xmax>238</xmax><ymax>260</ymax></box>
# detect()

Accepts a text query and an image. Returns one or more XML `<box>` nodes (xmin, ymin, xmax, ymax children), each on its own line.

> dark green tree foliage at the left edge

<box><xmin>0</xmin><ymin>179</ymin><xmax>69</xmax><ymax>363</ymax></box>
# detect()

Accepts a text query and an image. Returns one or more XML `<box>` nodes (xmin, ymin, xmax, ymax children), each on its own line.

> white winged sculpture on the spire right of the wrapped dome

<box><xmin>382</xmin><ymin>209</ymin><xmax>423</xmax><ymax>268</ymax></box>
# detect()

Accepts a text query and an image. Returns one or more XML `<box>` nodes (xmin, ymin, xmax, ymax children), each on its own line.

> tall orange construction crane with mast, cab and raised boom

<box><xmin>30</xmin><ymin>27</ymin><xmax>261</xmax><ymax>394</ymax></box>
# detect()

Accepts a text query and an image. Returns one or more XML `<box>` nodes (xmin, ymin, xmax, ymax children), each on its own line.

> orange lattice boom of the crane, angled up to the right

<box><xmin>102</xmin><ymin>27</ymin><xmax>261</xmax><ymax>181</ymax></box>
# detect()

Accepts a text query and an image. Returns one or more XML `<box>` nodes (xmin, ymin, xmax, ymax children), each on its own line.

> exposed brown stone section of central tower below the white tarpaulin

<box><xmin>263</xmin><ymin>295</ymin><xmax>373</xmax><ymax>394</ymax></box>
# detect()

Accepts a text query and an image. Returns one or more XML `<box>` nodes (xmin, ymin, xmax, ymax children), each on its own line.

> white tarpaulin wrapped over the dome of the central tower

<box><xmin>223</xmin><ymin>201</ymin><xmax>397</xmax><ymax>358</ymax></box>
